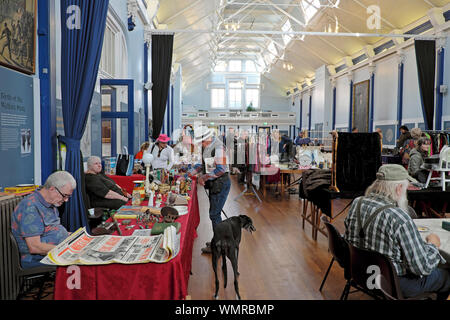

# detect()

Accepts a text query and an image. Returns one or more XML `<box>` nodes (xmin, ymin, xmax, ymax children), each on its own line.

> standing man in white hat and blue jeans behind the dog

<box><xmin>190</xmin><ymin>126</ymin><xmax>231</xmax><ymax>253</ymax></box>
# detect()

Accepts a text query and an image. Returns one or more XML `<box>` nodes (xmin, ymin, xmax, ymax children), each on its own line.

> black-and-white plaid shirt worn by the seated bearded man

<box><xmin>344</xmin><ymin>193</ymin><xmax>445</xmax><ymax>276</ymax></box>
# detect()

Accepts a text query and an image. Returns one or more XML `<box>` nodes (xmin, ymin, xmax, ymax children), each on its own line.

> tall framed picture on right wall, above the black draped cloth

<box><xmin>352</xmin><ymin>80</ymin><xmax>370</xmax><ymax>132</ymax></box>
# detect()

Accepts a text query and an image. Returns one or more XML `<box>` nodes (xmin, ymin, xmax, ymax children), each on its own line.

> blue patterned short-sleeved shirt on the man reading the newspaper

<box><xmin>11</xmin><ymin>190</ymin><xmax>69</xmax><ymax>263</ymax></box>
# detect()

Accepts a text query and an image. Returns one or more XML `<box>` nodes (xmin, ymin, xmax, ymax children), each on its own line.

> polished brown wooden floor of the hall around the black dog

<box><xmin>188</xmin><ymin>176</ymin><xmax>368</xmax><ymax>300</ymax></box>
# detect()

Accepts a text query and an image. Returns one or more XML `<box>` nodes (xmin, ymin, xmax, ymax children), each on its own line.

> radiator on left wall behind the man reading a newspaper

<box><xmin>0</xmin><ymin>196</ymin><xmax>24</xmax><ymax>300</ymax></box>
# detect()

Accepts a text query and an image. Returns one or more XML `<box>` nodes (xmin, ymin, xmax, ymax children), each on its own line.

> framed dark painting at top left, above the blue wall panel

<box><xmin>0</xmin><ymin>0</ymin><xmax>36</xmax><ymax>74</ymax></box>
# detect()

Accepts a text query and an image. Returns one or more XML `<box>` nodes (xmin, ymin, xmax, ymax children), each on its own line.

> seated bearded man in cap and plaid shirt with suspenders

<box><xmin>344</xmin><ymin>164</ymin><xmax>450</xmax><ymax>299</ymax></box>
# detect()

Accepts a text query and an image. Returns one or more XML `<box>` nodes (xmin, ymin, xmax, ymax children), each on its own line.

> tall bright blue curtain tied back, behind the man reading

<box><xmin>61</xmin><ymin>0</ymin><xmax>109</xmax><ymax>231</ymax></box>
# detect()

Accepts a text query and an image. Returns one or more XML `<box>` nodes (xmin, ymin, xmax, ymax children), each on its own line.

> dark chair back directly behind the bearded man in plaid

<box><xmin>349</xmin><ymin>244</ymin><xmax>403</xmax><ymax>299</ymax></box>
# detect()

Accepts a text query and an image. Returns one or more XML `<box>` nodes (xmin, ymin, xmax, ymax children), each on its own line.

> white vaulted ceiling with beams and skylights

<box><xmin>156</xmin><ymin>0</ymin><xmax>450</xmax><ymax>89</ymax></box>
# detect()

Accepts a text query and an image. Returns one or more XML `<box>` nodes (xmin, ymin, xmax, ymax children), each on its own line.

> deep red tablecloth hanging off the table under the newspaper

<box><xmin>54</xmin><ymin>182</ymin><xmax>200</xmax><ymax>300</ymax></box>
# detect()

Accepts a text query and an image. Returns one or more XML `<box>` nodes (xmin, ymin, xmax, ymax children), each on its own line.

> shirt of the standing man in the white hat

<box><xmin>189</xmin><ymin>137</ymin><xmax>229</xmax><ymax>180</ymax></box>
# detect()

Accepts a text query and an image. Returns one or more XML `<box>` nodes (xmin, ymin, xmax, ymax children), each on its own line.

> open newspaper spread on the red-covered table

<box><xmin>41</xmin><ymin>226</ymin><xmax>180</xmax><ymax>266</ymax></box>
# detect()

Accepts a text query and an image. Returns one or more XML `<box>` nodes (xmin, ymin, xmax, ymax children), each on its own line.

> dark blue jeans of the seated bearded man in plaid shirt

<box><xmin>399</xmin><ymin>268</ymin><xmax>450</xmax><ymax>300</ymax></box>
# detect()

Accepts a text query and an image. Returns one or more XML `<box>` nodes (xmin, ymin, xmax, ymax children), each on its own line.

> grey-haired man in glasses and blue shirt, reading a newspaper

<box><xmin>11</xmin><ymin>171</ymin><xmax>77</xmax><ymax>268</ymax></box>
